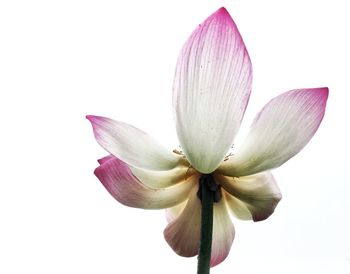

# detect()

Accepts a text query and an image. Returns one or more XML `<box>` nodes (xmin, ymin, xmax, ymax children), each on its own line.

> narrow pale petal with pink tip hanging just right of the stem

<box><xmin>210</xmin><ymin>200</ymin><xmax>235</xmax><ymax>267</ymax></box>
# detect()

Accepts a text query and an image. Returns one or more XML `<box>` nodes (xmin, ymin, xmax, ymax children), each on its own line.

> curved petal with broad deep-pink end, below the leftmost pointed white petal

<box><xmin>95</xmin><ymin>157</ymin><xmax>197</xmax><ymax>209</ymax></box>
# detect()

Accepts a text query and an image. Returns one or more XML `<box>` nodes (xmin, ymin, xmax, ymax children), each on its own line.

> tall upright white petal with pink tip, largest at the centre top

<box><xmin>173</xmin><ymin>8</ymin><xmax>252</xmax><ymax>173</ymax></box>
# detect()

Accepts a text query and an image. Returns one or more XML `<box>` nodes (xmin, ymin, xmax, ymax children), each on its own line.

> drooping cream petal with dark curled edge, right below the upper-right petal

<box><xmin>216</xmin><ymin>171</ymin><xmax>282</xmax><ymax>222</ymax></box>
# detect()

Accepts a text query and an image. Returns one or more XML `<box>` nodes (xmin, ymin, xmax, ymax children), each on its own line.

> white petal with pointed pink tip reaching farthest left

<box><xmin>86</xmin><ymin>115</ymin><xmax>181</xmax><ymax>170</ymax></box>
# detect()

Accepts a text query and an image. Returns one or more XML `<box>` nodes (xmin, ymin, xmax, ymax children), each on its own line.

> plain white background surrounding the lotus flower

<box><xmin>0</xmin><ymin>0</ymin><xmax>350</xmax><ymax>274</ymax></box>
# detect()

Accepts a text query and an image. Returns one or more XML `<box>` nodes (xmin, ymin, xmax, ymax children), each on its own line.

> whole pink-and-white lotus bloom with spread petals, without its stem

<box><xmin>87</xmin><ymin>8</ymin><xmax>328</xmax><ymax>266</ymax></box>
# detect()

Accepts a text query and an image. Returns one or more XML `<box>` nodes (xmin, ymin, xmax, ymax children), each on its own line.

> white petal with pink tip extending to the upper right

<box><xmin>219</xmin><ymin>88</ymin><xmax>328</xmax><ymax>177</ymax></box>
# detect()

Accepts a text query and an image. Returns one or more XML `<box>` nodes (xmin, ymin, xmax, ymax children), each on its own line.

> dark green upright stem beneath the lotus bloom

<box><xmin>197</xmin><ymin>174</ymin><xmax>217</xmax><ymax>274</ymax></box>
